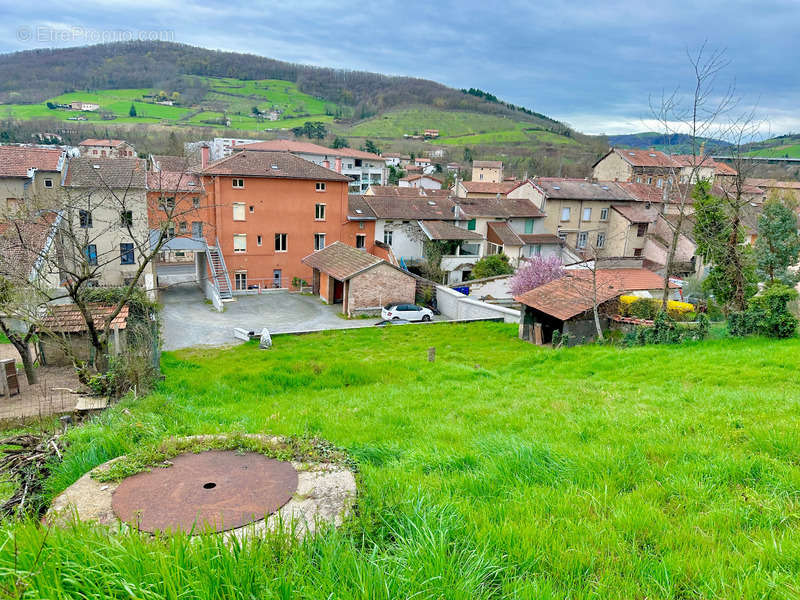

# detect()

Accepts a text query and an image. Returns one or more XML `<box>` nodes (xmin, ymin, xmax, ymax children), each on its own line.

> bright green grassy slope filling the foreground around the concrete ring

<box><xmin>0</xmin><ymin>323</ymin><xmax>800</xmax><ymax>599</ymax></box>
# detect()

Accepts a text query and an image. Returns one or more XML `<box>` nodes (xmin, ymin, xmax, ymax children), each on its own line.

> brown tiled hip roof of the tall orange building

<box><xmin>202</xmin><ymin>150</ymin><xmax>350</xmax><ymax>181</ymax></box>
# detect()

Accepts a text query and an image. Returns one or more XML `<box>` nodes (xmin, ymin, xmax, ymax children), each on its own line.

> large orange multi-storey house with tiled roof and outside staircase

<box><xmin>200</xmin><ymin>149</ymin><xmax>356</xmax><ymax>297</ymax></box>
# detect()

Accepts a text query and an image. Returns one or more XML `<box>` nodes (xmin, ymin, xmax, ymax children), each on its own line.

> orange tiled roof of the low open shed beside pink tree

<box><xmin>514</xmin><ymin>269</ymin><xmax>664</xmax><ymax>321</ymax></box>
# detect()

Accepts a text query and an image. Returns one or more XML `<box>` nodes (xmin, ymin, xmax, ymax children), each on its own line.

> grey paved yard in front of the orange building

<box><xmin>160</xmin><ymin>284</ymin><xmax>380</xmax><ymax>350</ymax></box>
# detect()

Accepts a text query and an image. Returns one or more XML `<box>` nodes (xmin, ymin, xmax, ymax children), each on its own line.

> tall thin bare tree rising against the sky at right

<box><xmin>650</xmin><ymin>43</ymin><xmax>737</xmax><ymax>310</ymax></box>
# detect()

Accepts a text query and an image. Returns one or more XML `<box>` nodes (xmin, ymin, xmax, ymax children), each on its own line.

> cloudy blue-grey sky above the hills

<box><xmin>0</xmin><ymin>0</ymin><xmax>800</xmax><ymax>134</ymax></box>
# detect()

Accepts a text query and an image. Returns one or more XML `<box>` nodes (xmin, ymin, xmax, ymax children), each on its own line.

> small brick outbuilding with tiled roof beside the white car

<box><xmin>302</xmin><ymin>241</ymin><xmax>416</xmax><ymax>317</ymax></box>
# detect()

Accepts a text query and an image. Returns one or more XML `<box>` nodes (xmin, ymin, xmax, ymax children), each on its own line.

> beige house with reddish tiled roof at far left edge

<box><xmin>0</xmin><ymin>145</ymin><xmax>67</xmax><ymax>219</ymax></box>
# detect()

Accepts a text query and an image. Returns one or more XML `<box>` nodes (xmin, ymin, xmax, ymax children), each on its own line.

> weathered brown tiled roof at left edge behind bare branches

<box><xmin>0</xmin><ymin>212</ymin><xmax>58</xmax><ymax>281</ymax></box>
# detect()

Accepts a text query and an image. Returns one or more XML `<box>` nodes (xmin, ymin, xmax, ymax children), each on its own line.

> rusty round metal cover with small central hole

<box><xmin>112</xmin><ymin>450</ymin><xmax>297</xmax><ymax>533</ymax></box>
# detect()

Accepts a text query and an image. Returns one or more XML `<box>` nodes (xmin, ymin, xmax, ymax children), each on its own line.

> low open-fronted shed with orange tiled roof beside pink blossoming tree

<box><xmin>514</xmin><ymin>262</ymin><xmax>676</xmax><ymax>345</ymax></box>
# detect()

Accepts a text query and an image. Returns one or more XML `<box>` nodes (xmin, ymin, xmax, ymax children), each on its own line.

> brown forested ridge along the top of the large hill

<box><xmin>0</xmin><ymin>42</ymin><xmax>561</xmax><ymax>129</ymax></box>
